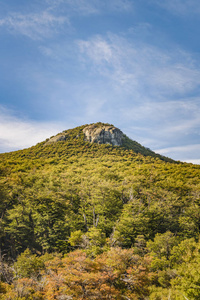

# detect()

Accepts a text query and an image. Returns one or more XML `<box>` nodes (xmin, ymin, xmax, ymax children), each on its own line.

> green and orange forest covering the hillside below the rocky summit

<box><xmin>0</xmin><ymin>126</ymin><xmax>200</xmax><ymax>300</ymax></box>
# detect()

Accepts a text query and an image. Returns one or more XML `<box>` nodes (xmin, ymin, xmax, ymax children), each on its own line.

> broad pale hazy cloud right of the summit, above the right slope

<box><xmin>121</xmin><ymin>98</ymin><xmax>200</xmax><ymax>151</ymax></box>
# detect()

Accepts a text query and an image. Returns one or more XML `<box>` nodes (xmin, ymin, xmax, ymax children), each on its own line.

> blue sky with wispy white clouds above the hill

<box><xmin>0</xmin><ymin>0</ymin><xmax>200</xmax><ymax>164</ymax></box>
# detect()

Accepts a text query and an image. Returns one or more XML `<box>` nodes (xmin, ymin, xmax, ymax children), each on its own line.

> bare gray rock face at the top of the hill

<box><xmin>83</xmin><ymin>124</ymin><xmax>123</xmax><ymax>146</ymax></box>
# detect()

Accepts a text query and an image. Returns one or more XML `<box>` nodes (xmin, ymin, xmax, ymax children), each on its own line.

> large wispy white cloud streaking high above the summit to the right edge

<box><xmin>78</xmin><ymin>35</ymin><xmax>200</xmax><ymax>96</ymax></box>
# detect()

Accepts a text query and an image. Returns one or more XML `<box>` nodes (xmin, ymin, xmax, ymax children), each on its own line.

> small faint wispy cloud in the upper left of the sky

<box><xmin>0</xmin><ymin>11</ymin><xmax>69</xmax><ymax>40</ymax></box>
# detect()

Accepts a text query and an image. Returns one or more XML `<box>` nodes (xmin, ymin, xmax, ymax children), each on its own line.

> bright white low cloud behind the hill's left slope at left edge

<box><xmin>0</xmin><ymin>107</ymin><xmax>63</xmax><ymax>152</ymax></box>
